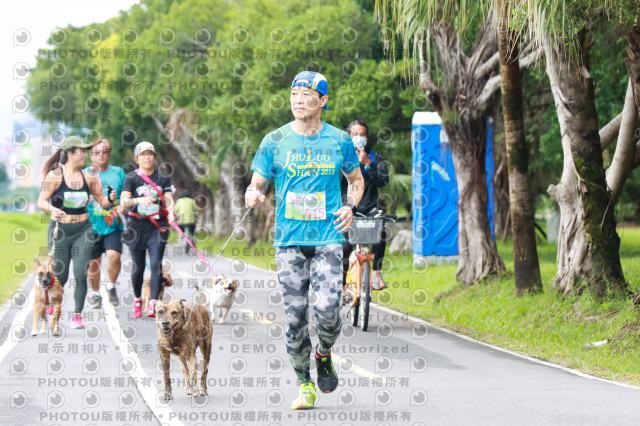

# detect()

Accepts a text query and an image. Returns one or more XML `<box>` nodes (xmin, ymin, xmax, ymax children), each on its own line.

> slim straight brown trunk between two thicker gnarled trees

<box><xmin>498</xmin><ymin>0</ymin><xmax>542</xmax><ymax>296</ymax></box>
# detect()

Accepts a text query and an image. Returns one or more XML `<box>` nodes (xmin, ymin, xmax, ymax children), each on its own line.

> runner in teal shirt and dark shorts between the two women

<box><xmin>84</xmin><ymin>139</ymin><xmax>125</xmax><ymax>309</ymax></box>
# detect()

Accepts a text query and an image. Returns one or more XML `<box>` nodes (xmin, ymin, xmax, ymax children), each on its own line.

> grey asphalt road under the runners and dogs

<box><xmin>0</xmin><ymin>243</ymin><xmax>640</xmax><ymax>426</ymax></box>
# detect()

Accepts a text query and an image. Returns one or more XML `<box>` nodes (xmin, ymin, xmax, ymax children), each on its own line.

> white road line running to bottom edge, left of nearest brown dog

<box><xmin>100</xmin><ymin>286</ymin><xmax>184</xmax><ymax>426</ymax></box>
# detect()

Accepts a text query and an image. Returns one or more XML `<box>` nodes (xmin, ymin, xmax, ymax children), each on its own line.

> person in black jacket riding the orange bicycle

<box><xmin>342</xmin><ymin>120</ymin><xmax>389</xmax><ymax>290</ymax></box>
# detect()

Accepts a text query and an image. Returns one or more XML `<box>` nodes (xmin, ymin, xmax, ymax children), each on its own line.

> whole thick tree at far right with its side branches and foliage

<box><xmin>527</xmin><ymin>0</ymin><xmax>638</xmax><ymax>296</ymax></box>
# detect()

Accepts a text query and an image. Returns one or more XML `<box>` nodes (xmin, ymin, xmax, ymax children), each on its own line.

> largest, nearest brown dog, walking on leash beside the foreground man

<box><xmin>154</xmin><ymin>299</ymin><xmax>213</xmax><ymax>400</ymax></box>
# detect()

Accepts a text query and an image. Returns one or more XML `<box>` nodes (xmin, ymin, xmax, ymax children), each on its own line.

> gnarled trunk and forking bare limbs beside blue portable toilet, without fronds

<box><xmin>418</xmin><ymin>20</ymin><xmax>505</xmax><ymax>285</ymax></box>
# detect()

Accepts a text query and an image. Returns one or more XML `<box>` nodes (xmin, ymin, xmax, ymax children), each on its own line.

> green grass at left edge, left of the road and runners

<box><xmin>0</xmin><ymin>213</ymin><xmax>49</xmax><ymax>304</ymax></box>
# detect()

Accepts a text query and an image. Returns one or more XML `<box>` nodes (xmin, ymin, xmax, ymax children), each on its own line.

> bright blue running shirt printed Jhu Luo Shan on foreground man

<box><xmin>251</xmin><ymin>122</ymin><xmax>360</xmax><ymax>247</ymax></box>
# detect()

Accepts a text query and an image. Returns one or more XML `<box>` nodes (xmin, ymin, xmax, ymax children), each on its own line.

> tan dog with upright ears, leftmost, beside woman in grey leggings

<box><xmin>31</xmin><ymin>256</ymin><xmax>62</xmax><ymax>336</ymax></box>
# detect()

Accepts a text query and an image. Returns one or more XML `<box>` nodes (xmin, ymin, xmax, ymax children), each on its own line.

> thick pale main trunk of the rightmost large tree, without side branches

<box><xmin>544</xmin><ymin>30</ymin><xmax>627</xmax><ymax>297</ymax></box>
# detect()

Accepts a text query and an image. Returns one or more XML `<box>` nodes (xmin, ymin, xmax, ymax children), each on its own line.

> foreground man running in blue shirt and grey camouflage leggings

<box><xmin>245</xmin><ymin>71</ymin><xmax>364</xmax><ymax>410</ymax></box>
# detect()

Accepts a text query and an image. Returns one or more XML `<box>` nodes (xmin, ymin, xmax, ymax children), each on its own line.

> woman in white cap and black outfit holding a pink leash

<box><xmin>120</xmin><ymin>142</ymin><xmax>175</xmax><ymax>318</ymax></box>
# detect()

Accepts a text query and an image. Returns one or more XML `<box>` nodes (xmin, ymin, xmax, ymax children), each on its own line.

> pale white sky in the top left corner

<box><xmin>0</xmin><ymin>0</ymin><xmax>139</xmax><ymax>143</ymax></box>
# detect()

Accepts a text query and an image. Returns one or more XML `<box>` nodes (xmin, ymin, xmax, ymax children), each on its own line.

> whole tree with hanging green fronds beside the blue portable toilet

<box><xmin>376</xmin><ymin>0</ymin><xmax>535</xmax><ymax>284</ymax></box>
